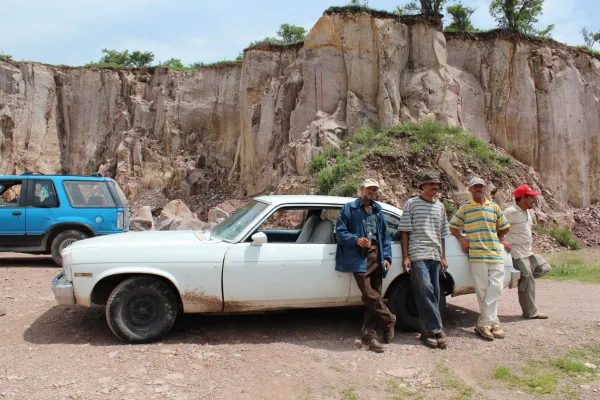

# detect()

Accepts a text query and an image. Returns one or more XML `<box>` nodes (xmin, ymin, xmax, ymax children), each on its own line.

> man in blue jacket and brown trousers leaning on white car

<box><xmin>335</xmin><ymin>179</ymin><xmax>396</xmax><ymax>353</ymax></box>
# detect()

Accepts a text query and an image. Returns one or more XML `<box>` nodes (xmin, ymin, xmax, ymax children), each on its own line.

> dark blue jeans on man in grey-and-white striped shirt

<box><xmin>410</xmin><ymin>260</ymin><xmax>442</xmax><ymax>333</ymax></box>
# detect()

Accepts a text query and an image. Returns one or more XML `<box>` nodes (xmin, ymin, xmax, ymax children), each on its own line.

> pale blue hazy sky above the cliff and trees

<box><xmin>0</xmin><ymin>0</ymin><xmax>600</xmax><ymax>66</ymax></box>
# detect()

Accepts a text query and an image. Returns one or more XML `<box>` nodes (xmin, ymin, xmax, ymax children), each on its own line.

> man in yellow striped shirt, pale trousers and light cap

<box><xmin>450</xmin><ymin>178</ymin><xmax>511</xmax><ymax>340</ymax></box>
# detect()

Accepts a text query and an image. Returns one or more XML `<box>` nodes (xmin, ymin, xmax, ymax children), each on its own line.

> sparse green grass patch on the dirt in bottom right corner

<box><xmin>494</xmin><ymin>346</ymin><xmax>600</xmax><ymax>398</ymax></box>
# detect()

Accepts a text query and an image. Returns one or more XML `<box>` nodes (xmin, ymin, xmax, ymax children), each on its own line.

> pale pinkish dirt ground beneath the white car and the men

<box><xmin>0</xmin><ymin>255</ymin><xmax>600</xmax><ymax>400</ymax></box>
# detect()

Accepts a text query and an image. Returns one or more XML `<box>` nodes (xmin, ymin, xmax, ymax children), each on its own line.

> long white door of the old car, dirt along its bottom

<box><xmin>223</xmin><ymin>208</ymin><xmax>352</xmax><ymax>311</ymax></box>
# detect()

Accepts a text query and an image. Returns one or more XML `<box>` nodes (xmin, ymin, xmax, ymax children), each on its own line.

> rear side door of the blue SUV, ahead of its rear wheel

<box><xmin>26</xmin><ymin>179</ymin><xmax>60</xmax><ymax>246</ymax></box>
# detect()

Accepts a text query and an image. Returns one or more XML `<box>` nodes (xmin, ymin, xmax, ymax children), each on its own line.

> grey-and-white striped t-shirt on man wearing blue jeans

<box><xmin>398</xmin><ymin>196</ymin><xmax>450</xmax><ymax>261</ymax></box>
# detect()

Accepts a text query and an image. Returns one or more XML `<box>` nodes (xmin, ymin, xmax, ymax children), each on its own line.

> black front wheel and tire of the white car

<box><xmin>106</xmin><ymin>277</ymin><xmax>177</xmax><ymax>343</ymax></box>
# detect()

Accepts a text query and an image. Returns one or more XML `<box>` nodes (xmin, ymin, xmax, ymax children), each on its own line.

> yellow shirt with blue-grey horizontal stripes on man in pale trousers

<box><xmin>449</xmin><ymin>199</ymin><xmax>510</xmax><ymax>263</ymax></box>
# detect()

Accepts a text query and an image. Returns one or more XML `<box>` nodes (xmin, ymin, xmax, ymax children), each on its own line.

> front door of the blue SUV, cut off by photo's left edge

<box><xmin>0</xmin><ymin>179</ymin><xmax>27</xmax><ymax>250</ymax></box>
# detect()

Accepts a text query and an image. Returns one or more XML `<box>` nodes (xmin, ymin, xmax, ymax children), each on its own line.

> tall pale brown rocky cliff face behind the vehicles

<box><xmin>0</xmin><ymin>13</ymin><xmax>600</xmax><ymax>206</ymax></box>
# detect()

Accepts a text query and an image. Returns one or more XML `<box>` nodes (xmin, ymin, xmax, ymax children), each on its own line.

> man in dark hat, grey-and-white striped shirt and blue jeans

<box><xmin>398</xmin><ymin>173</ymin><xmax>450</xmax><ymax>348</ymax></box>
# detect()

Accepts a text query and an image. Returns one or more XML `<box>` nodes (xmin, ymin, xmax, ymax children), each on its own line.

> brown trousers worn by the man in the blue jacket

<box><xmin>354</xmin><ymin>246</ymin><xmax>394</xmax><ymax>341</ymax></box>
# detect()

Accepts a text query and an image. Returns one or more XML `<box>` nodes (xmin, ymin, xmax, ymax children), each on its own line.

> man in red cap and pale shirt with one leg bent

<box><xmin>504</xmin><ymin>185</ymin><xmax>551</xmax><ymax>319</ymax></box>
